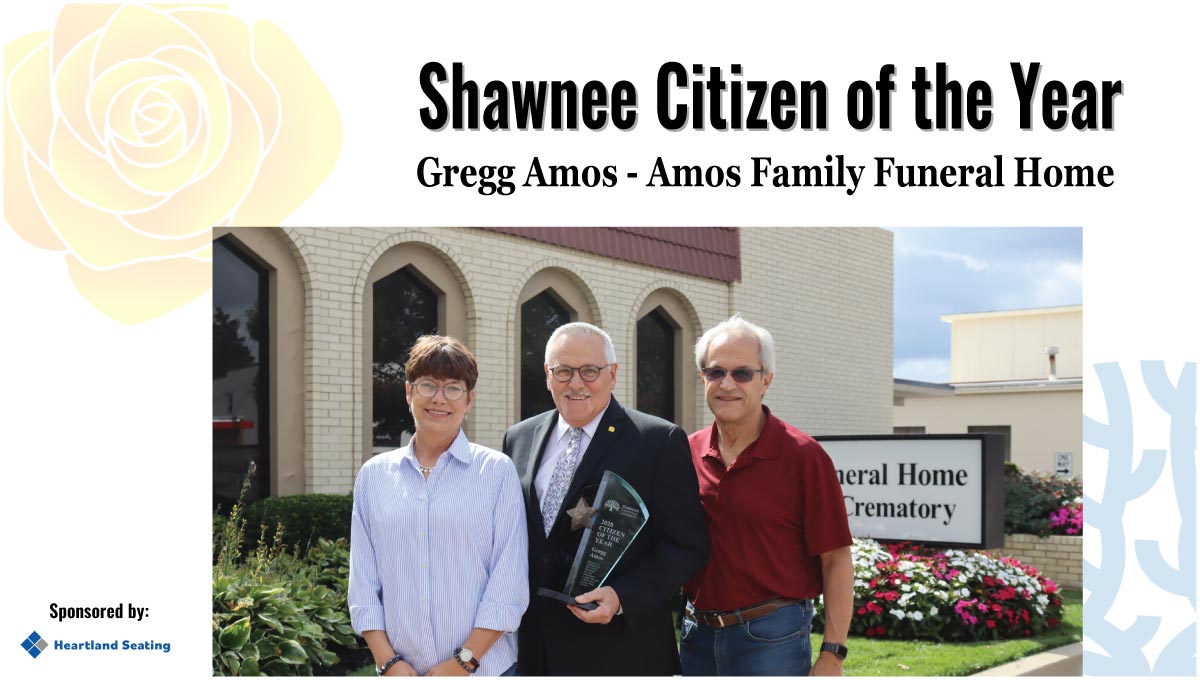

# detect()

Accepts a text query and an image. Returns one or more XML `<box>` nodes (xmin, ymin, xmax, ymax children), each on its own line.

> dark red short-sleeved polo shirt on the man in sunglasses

<box><xmin>684</xmin><ymin>407</ymin><xmax>851</xmax><ymax>612</ymax></box>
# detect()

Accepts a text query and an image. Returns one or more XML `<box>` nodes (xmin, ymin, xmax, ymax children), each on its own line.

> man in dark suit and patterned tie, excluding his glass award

<box><xmin>503</xmin><ymin>323</ymin><xmax>708</xmax><ymax>675</ymax></box>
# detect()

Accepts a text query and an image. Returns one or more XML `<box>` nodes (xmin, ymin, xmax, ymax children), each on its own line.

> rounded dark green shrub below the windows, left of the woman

<box><xmin>245</xmin><ymin>493</ymin><xmax>354</xmax><ymax>553</ymax></box>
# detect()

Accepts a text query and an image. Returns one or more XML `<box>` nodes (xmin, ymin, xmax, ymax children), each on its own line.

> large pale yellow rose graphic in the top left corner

<box><xmin>4</xmin><ymin>5</ymin><xmax>342</xmax><ymax>324</ymax></box>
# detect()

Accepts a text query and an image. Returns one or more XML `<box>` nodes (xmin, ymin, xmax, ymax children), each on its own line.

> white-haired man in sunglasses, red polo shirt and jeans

<box><xmin>679</xmin><ymin>315</ymin><xmax>854</xmax><ymax>675</ymax></box>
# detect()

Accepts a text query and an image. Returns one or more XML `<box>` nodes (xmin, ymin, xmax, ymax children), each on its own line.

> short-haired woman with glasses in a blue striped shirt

<box><xmin>348</xmin><ymin>336</ymin><xmax>529</xmax><ymax>675</ymax></box>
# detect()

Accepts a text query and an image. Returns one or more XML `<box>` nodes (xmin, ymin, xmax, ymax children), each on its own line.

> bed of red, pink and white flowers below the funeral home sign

<box><xmin>818</xmin><ymin>540</ymin><xmax>1062</xmax><ymax>640</ymax></box>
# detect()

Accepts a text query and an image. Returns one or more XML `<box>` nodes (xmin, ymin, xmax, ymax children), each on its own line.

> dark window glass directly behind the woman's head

<box><xmin>371</xmin><ymin>266</ymin><xmax>438</xmax><ymax>450</ymax></box>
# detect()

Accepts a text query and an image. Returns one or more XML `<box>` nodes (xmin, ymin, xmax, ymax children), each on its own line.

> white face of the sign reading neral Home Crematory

<box><xmin>821</xmin><ymin>438</ymin><xmax>988</xmax><ymax>544</ymax></box>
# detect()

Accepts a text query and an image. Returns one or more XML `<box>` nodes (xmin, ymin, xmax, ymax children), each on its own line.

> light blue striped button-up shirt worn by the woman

<box><xmin>349</xmin><ymin>432</ymin><xmax>529</xmax><ymax>675</ymax></box>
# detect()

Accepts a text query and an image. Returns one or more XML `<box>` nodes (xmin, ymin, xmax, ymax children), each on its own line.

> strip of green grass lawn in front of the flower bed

<box><xmin>840</xmin><ymin>590</ymin><xmax>1084</xmax><ymax>675</ymax></box>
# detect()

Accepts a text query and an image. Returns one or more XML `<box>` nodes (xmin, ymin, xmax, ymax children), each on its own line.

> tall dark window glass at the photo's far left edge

<box><xmin>212</xmin><ymin>237</ymin><xmax>271</xmax><ymax>512</ymax></box>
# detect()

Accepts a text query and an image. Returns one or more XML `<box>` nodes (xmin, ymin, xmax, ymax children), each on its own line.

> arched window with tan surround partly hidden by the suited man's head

<box><xmin>512</xmin><ymin>267</ymin><xmax>599</xmax><ymax>422</ymax></box>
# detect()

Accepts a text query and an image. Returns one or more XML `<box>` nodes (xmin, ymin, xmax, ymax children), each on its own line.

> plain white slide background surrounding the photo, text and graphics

<box><xmin>0</xmin><ymin>1</ymin><xmax>1200</xmax><ymax>678</ymax></box>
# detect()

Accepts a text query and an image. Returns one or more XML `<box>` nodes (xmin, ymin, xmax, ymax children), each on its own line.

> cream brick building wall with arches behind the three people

<box><xmin>226</xmin><ymin>228</ymin><xmax>892</xmax><ymax>493</ymax></box>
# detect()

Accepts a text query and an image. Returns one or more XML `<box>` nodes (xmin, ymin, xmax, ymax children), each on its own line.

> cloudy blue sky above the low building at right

<box><xmin>892</xmin><ymin>227</ymin><xmax>1084</xmax><ymax>383</ymax></box>
